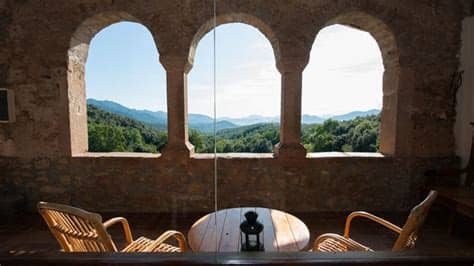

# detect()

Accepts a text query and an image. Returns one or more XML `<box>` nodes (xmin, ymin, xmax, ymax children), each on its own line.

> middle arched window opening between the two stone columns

<box><xmin>188</xmin><ymin>23</ymin><xmax>280</xmax><ymax>153</ymax></box>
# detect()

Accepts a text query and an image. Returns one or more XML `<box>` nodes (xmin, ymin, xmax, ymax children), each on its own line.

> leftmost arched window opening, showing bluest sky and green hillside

<box><xmin>85</xmin><ymin>22</ymin><xmax>167</xmax><ymax>153</ymax></box>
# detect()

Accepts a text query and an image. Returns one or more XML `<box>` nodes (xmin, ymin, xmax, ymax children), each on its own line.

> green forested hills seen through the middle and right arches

<box><xmin>190</xmin><ymin>115</ymin><xmax>380</xmax><ymax>153</ymax></box>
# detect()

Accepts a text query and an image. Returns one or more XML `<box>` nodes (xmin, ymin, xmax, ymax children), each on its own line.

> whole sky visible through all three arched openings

<box><xmin>85</xmin><ymin>22</ymin><xmax>383</xmax><ymax>118</ymax></box>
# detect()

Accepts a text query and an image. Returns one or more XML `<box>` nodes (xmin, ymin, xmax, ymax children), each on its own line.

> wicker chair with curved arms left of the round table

<box><xmin>38</xmin><ymin>202</ymin><xmax>187</xmax><ymax>252</ymax></box>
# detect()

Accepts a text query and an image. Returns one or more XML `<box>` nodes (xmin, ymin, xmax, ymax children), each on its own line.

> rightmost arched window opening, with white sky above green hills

<box><xmin>301</xmin><ymin>24</ymin><xmax>384</xmax><ymax>152</ymax></box>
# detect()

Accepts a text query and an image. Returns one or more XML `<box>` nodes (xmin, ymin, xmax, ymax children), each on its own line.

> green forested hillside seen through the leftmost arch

<box><xmin>87</xmin><ymin>105</ymin><xmax>168</xmax><ymax>153</ymax></box>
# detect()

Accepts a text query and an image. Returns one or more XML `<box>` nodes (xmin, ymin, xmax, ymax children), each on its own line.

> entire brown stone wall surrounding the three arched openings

<box><xmin>0</xmin><ymin>0</ymin><xmax>471</xmax><ymax>212</ymax></box>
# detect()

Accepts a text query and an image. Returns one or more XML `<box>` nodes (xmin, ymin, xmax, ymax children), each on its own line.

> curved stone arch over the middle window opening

<box><xmin>188</xmin><ymin>13</ymin><xmax>280</xmax><ymax>69</ymax></box>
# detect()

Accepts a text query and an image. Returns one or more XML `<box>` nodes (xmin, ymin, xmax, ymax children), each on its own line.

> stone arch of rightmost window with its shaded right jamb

<box><xmin>313</xmin><ymin>11</ymin><xmax>400</xmax><ymax>155</ymax></box>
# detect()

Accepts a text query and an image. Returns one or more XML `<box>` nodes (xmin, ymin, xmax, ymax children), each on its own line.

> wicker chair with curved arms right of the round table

<box><xmin>313</xmin><ymin>190</ymin><xmax>438</xmax><ymax>252</ymax></box>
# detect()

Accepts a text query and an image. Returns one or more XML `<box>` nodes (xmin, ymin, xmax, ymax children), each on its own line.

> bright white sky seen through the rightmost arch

<box><xmin>302</xmin><ymin>25</ymin><xmax>384</xmax><ymax>115</ymax></box>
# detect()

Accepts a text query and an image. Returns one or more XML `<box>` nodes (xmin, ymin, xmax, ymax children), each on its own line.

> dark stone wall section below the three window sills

<box><xmin>0</xmin><ymin>156</ymin><xmax>460</xmax><ymax>213</ymax></box>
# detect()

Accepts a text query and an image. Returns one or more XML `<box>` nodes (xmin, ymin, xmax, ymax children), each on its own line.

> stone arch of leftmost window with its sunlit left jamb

<box><xmin>67</xmin><ymin>11</ymin><xmax>158</xmax><ymax>155</ymax></box>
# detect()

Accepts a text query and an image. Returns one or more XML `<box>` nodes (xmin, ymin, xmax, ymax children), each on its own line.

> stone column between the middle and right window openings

<box><xmin>275</xmin><ymin>57</ymin><xmax>308</xmax><ymax>158</ymax></box>
